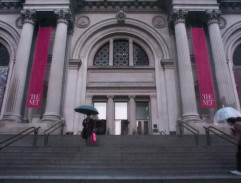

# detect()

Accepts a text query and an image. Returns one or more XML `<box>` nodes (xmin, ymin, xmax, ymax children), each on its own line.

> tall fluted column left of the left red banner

<box><xmin>3</xmin><ymin>10</ymin><xmax>36</xmax><ymax>121</ymax></box>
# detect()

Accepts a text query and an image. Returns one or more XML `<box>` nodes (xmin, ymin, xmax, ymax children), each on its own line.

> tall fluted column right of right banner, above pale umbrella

<box><xmin>206</xmin><ymin>10</ymin><xmax>237</xmax><ymax>107</ymax></box>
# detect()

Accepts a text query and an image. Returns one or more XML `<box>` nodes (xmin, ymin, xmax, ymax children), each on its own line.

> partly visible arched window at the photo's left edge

<box><xmin>0</xmin><ymin>43</ymin><xmax>9</xmax><ymax>108</ymax></box>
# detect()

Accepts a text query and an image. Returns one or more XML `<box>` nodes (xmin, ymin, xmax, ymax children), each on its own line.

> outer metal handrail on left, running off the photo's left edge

<box><xmin>0</xmin><ymin>127</ymin><xmax>40</xmax><ymax>150</ymax></box>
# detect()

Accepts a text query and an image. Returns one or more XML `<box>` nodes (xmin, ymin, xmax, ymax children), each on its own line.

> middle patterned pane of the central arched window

<box><xmin>113</xmin><ymin>40</ymin><xmax>129</xmax><ymax>66</ymax></box>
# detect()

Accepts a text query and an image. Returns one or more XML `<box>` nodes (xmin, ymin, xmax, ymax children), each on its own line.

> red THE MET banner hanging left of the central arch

<box><xmin>27</xmin><ymin>28</ymin><xmax>52</xmax><ymax>108</ymax></box>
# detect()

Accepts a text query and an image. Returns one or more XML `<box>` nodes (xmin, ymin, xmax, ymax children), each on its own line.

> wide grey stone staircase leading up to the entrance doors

<box><xmin>0</xmin><ymin>135</ymin><xmax>241</xmax><ymax>183</ymax></box>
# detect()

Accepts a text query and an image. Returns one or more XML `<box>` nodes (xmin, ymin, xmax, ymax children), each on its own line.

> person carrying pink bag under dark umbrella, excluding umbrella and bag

<box><xmin>82</xmin><ymin>114</ymin><xmax>94</xmax><ymax>145</ymax></box>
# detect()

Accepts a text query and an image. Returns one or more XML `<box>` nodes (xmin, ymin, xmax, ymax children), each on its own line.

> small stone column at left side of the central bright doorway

<box><xmin>106</xmin><ymin>96</ymin><xmax>115</xmax><ymax>134</ymax></box>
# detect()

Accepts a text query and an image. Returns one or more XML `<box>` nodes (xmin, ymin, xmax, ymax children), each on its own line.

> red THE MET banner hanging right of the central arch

<box><xmin>192</xmin><ymin>28</ymin><xmax>216</xmax><ymax>108</ymax></box>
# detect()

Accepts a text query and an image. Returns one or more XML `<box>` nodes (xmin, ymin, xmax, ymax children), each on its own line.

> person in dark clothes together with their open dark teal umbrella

<box><xmin>74</xmin><ymin>105</ymin><xmax>99</xmax><ymax>146</ymax></box>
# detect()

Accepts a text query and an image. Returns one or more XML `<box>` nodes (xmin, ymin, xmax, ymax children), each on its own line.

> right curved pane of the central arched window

<box><xmin>133</xmin><ymin>43</ymin><xmax>149</xmax><ymax>65</ymax></box>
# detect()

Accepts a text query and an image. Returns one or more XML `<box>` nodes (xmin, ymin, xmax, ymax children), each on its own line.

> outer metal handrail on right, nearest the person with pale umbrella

<box><xmin>203</xmin><ymin>126</ymin><xmax>237</xmax><ymax>146</ymax></box>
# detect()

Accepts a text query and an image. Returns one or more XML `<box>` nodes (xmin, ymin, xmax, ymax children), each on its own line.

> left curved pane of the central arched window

<box><xmin>94</xmin><ymin>43</ymin><xmax>110</xmax><ymax>66</ymax></box>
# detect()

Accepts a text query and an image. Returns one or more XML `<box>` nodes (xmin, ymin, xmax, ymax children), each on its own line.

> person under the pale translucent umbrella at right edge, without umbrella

<box><xmin>227</xmin><ymin>117</ymin><xmax>241</xmax><ymax>175</ymax></box>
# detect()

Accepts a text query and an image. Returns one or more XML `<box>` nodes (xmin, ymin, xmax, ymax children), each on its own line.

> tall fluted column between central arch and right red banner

<box><xmin>173</xmin><ymin>10</ymin><xmax>199</xmax><ymax>121</ymax></box>
